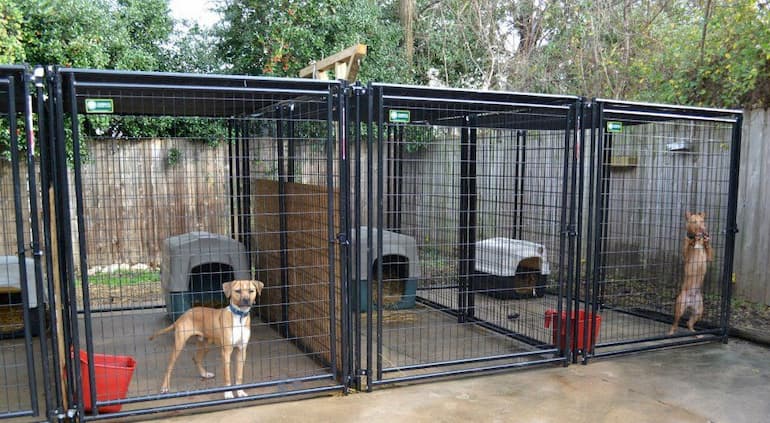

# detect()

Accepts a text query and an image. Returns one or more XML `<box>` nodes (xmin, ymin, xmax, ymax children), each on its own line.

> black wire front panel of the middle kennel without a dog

<box><xmin>349</xmin><ymin>84</ymin><xmax>580</xmax><ymax>387</ymax></box>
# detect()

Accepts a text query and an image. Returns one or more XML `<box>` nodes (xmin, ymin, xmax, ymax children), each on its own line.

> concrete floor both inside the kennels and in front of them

<box><xmin>0</xmin><ymin>296</ymin><xmax>770</xmax><ymax>423</ymax></box>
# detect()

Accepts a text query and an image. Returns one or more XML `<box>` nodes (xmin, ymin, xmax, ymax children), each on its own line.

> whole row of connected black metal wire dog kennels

<box><xmin>0</xmin><ymin>62</ymin><xmax>741</xmax><ymax>420</ymax></box>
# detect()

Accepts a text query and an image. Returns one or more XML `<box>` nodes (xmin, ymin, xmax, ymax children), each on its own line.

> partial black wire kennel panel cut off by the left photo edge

<box><xmin>0</xmin><ymin>66</ymin><xmax>50</xmax><ymax>420</ymax></box>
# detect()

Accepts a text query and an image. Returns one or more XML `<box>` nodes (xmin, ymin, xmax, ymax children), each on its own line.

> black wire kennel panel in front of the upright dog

<box><xmin>576</xmin><ymin>100</ymin><xmax>741</xmax><ymax>357</ymax></box>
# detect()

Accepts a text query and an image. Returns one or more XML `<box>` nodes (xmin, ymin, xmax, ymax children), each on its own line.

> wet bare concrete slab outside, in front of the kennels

<box><xmin>146</xmin><ymin>340</ymin><xmax>770</xmax><ymax>423</ymax></box>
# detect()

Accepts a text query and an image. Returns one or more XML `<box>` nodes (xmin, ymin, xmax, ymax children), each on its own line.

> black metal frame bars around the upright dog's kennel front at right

<box><xmin>575</xmin><ymin>99</ymin><xmax>743</xmax><ymax>364</ymax></box>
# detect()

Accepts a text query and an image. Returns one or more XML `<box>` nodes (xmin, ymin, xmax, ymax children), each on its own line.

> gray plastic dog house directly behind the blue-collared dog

<box><xmin>160</xmin><ymin>232</ymin><xmax>251</xmax><ymax>321</ymax></box>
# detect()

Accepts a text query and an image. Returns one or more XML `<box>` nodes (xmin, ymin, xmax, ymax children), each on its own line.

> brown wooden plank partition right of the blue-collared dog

<box><xmin>253</xmin><ymin>180</ymin><xmax>342</xmax><ymax>366</ymax></box>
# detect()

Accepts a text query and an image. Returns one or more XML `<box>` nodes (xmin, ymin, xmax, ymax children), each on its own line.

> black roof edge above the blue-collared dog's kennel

<box><xmin>58</xmin><ymin>68</ymin><xmax>340</xmax><ymax>119</ymax></box>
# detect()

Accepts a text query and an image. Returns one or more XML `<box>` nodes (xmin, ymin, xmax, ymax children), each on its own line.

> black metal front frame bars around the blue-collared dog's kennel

<box><xmin>49</xmin><ymin>68</ymin><xmax>346</xmax><ymax>420</ymax></box>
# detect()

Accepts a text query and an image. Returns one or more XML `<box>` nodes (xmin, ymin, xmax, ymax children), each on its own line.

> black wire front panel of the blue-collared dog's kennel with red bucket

<box><xmin>49</xmin><ymin>69</ymin><xmax>344</xmax><ymax>419</ymax></box>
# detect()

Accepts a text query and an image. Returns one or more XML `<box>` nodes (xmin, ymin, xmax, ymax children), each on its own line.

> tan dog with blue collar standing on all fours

<box><xmin>150</xmin><ymin>280</ymin><xmax>265</xmax><ymax>398</ymax></box>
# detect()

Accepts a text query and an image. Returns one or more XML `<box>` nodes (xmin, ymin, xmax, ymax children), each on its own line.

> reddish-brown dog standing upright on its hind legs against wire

<box><xmin>668</xmin><ymin>212</ymin><xmax>714</xmax><ymax>335</ymax></box>
